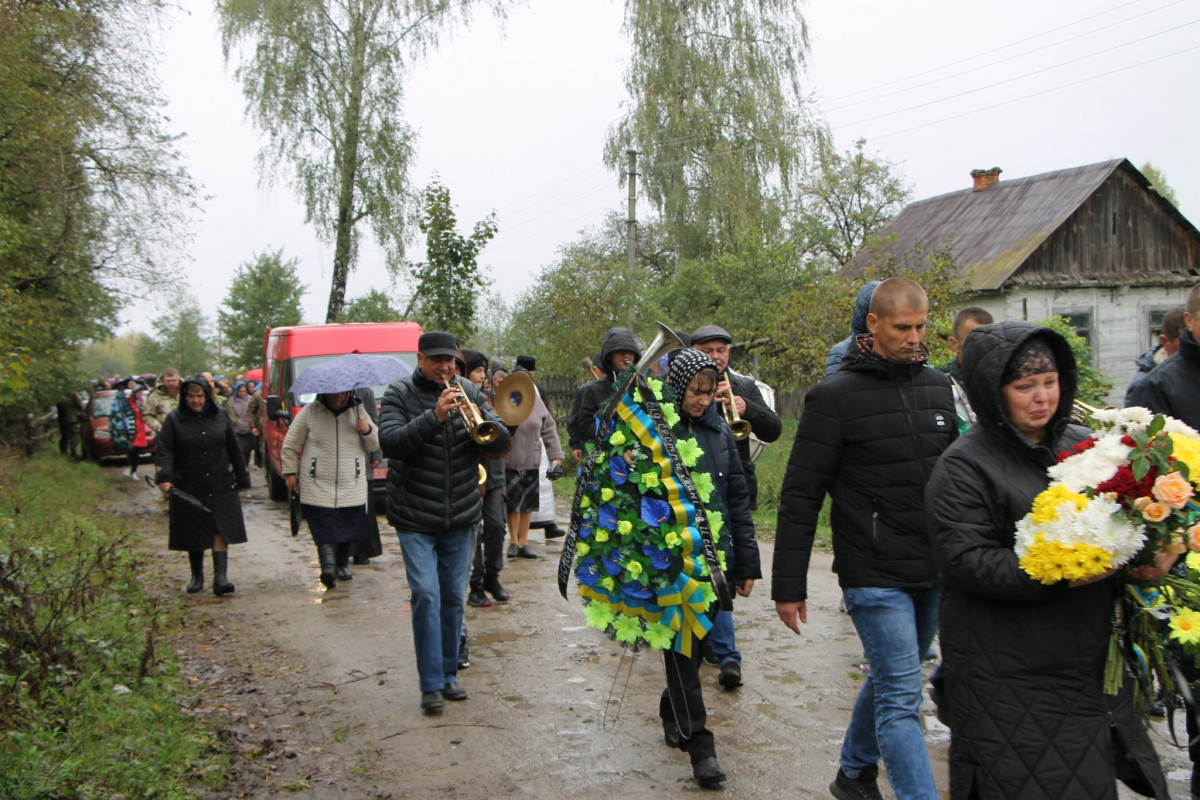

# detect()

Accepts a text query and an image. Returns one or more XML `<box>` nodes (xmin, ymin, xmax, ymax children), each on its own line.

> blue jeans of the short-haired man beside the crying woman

<box><xmin>841</xmin><ymin>589</ymin><xmax>937</xmax><ymax>800</ymax></box>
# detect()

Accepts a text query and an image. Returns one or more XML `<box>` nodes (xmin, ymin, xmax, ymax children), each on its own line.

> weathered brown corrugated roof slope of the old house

<box><xmin>842</xmin><ymin>158</ymin><xmax>1145</xmax><ymax>290</ymax></box>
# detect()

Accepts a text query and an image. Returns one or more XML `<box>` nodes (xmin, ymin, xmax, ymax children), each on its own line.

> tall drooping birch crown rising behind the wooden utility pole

<box><xmin>605</xmin><ymin>0</ymin><xmax>809</xmax><ymax>258</ymax></box>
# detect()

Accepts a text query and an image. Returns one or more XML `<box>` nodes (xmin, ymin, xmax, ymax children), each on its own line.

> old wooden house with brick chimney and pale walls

<box><xmin>841</xmin><ymin>158</ymin><xmax>1200</xmax><ymax>404</ymax></box>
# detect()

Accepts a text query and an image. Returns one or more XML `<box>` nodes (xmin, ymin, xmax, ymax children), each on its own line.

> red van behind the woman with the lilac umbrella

<box><xmin>259</xmin><ymin>323</ymin><xmax>421</xmax><ymax>500</ymax></box>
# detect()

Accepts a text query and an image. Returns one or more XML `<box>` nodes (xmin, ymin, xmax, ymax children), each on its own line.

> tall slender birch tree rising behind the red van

<box><xmin>217</xmin><ymin>0</ymin><xmax>502</xmax><ymax>323</ymax></box>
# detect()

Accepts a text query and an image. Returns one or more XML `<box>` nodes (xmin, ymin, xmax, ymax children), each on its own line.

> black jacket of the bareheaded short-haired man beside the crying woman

<box><xmin>770</xmin><ymin>335</ymin><xmax>958</xmax><ymax>602</ymax></box>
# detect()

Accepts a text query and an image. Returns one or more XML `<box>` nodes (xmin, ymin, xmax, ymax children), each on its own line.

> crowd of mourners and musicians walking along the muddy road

<box><xmin>65</xmin><ymin>278</ymin><xmax>1200</xmax><ymax>800</ymax></box>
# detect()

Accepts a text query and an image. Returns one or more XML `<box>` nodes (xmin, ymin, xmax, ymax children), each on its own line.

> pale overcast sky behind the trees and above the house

<box><xmin>131</xmin><ymin>0</ymin><xmax>1200</xmax><ymax>331</ymax></box>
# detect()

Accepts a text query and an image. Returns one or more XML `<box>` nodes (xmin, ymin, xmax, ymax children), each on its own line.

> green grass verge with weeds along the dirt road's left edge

<box><xmin>0</xmin><ymin>453</ymin><xmax>228</xmax><ymax>800</ymax></box>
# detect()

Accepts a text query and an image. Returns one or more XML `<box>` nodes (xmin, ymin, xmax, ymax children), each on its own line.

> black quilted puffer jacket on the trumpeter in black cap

<box><xmin>379</xmin><ymin>369</ymin><xmax>509</xmax><ymax>534</ymax></box>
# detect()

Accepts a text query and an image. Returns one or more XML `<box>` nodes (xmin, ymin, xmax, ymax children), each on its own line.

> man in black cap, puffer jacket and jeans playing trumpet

<box><xmin>379</xmin><ymin>331</ymin><xmax>509</xmax><ymax>712</ymax></box>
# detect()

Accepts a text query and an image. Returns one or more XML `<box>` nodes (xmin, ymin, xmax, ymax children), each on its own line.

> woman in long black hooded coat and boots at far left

<box><xmin>155</xmin><ymin>375</ymin><xmax>250</xmax><ymax>597</ymax></box>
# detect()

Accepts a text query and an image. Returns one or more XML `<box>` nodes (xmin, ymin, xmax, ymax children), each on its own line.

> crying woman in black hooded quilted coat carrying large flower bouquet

<box><xmin>925</xmin><ymin>321</ymin><xmax>1170</xmax><ymax>800</ymax></box>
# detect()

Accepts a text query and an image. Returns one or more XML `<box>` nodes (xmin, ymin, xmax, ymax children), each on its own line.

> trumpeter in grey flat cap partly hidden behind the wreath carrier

<box><xmin>691</xmin><ymin>325</ymin><xmax>784</xmax><ymax>688</ymax></box>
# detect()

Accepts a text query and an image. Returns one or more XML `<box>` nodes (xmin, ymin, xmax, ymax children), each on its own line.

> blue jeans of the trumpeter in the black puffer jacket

<box><xmin>396</xmin><ymin>528</ymin><xmax>470</xmax><ymax>692</ymax></box>
